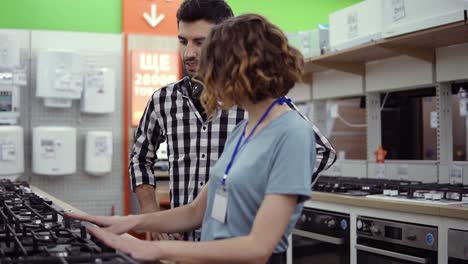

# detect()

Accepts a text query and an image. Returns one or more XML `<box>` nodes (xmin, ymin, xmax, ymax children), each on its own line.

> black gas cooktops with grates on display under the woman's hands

<box><xmin>0</xmin><ymin>180</ymin><xmax>138</xmax><ymax>264</ymax></box>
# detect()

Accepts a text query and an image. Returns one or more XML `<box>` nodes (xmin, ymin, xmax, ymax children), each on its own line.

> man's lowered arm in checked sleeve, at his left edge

<box><xmin>129</xmin><ymin>100</ymin><xmax>162</xmax><ymax>213</ymax></box>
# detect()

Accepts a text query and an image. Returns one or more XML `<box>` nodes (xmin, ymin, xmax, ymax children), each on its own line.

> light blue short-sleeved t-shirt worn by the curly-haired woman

<box><xmin>201</xmin><ymin>111</ymin><xmax>315</xmax><ymax>253</ymax></box>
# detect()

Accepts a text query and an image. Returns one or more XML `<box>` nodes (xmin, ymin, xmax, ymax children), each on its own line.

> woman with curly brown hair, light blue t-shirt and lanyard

<box><xmin>69</xmin><ymin>14</ymin><xmax>315</xmax><ymax>263</ymax></box>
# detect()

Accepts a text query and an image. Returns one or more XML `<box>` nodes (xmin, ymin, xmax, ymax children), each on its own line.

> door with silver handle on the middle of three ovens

<box><xmin>356</xmin><ymin>239</ymin><xmax>437</xmax><ymax>264</ymax></box>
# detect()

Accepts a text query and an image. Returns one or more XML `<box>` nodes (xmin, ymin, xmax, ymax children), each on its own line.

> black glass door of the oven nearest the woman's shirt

<box><xmin>292</xmin><ymin>229</ymin><xmax>350</xmax><ymax>264</ymax></box>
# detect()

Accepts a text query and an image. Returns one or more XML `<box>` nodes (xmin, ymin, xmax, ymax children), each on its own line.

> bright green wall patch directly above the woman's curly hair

<box><xmin>227</xmin><ymin>0</ymin><xmax>362</xmax><ymax>32</ymax></box>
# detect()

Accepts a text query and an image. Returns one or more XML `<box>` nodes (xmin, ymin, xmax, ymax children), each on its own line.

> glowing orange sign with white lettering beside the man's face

<box><xmin>130</xmin><ymin>50</ymin><xmax>179</xmax><ymax>126</ymax></box>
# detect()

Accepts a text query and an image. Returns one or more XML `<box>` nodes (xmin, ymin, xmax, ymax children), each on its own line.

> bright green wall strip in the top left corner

<box><xmin>0</xmin><ymin>0</ymin><xmax>122</xmax><ymax>33</ymax></box>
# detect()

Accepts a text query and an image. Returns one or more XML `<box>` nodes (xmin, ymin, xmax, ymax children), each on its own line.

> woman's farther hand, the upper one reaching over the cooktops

<box><xmin>65</xmin><ymin>213</ymin><xmax>138</xmax><ymax>235</ymax></box>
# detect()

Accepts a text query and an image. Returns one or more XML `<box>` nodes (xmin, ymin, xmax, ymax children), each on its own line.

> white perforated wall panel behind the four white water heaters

<box><xmin>26</xmin><ymin>31</ymin><xmax>124</xmax><ymax>215</ymax></box>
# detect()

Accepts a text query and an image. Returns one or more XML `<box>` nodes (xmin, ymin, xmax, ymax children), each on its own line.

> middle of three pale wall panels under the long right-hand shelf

<box><xmin>366</xmin><ymin>56</ymin><xmax>433</xmax><ymax>92</ymax></box>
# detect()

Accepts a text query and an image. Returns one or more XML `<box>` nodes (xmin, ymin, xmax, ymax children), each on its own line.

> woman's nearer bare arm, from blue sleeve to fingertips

<box><xmin>91</xmin><ymin>194</ymin><xmax>297</xmax><ymax>264</ymax></box>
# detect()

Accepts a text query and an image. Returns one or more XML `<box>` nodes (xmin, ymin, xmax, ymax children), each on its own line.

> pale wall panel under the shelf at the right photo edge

<box><xmin>436</xmin><ymin>43</ymin><xmax>468</xmax><ymax>82</ymax></box>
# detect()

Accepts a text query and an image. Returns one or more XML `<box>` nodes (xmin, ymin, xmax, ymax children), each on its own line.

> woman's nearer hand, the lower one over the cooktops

<box><xmin>87</xmin><ymin>227</ymin><xmax>161</xmax><ymax>261</ymax></box>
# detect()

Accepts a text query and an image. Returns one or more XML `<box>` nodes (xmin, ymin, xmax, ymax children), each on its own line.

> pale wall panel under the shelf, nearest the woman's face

<box><xmin>312</xmin><ymin>70</ymin><xmax>364</xmax><ymax>100</ymax></box>
